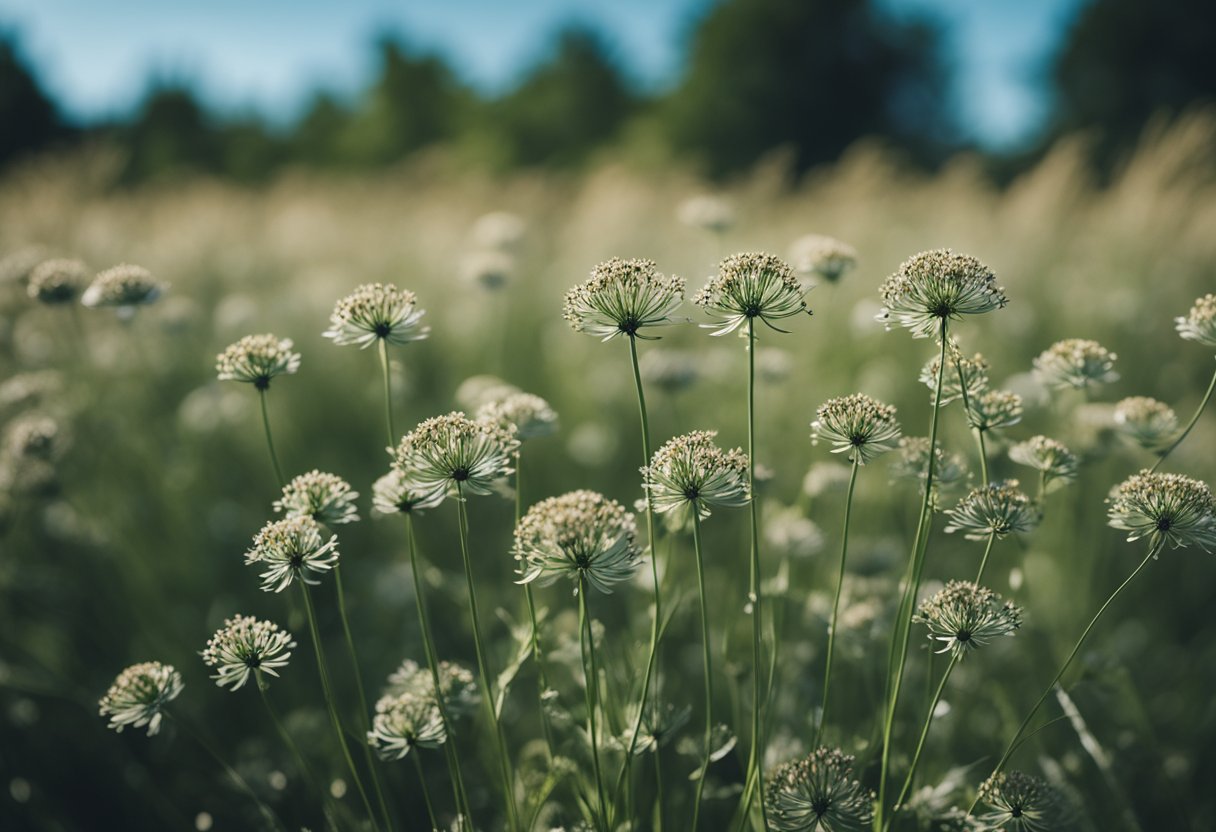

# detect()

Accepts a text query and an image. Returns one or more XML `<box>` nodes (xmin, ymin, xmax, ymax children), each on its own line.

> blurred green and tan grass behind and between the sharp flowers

<box><xmin>0</xmin><ymin>114</ymin><xmax>1216</xmax><ymax>831</ymax></box>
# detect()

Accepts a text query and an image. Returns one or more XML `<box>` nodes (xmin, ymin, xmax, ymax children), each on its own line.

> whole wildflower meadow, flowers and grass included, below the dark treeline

<box><xmin>7</xmin><ymin>116</ymin><xmax>1216</xmax><ymax>832</ymax></box>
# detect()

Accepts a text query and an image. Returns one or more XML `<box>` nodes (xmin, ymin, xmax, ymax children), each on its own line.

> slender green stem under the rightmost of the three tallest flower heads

<box><xmin>874</xmin><ymin>317</ymin><xmax>950</xmax><ymax>830</ymax></box>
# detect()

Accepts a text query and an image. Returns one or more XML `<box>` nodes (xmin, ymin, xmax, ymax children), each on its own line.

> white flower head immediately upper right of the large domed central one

<box><xmin>642</xmin><ymin>431</ymin><xmax>750</xmax><ymax>518</ymax></box>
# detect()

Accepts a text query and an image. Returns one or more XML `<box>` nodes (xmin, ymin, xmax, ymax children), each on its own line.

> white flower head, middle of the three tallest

<box><xmin>693</xmin><ymin>252</ymin><xmax>810</xmax><ymax>336</ymax></box>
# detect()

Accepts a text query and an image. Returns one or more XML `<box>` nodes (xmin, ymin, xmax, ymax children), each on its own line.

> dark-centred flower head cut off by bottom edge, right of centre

<box><xmin>765</xmin><ymin>748</ymin><xmax>874</xmax><ymax>832</ymax></box>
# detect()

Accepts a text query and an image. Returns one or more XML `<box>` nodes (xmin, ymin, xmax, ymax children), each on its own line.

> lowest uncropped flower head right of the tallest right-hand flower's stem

<box><xmin>913</xmin><ymin>580</ymin><xmax>1021</xmax><ymax>658</ymax></box>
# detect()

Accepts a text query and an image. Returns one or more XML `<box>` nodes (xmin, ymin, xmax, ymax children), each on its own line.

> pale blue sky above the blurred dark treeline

<box><xmin>0</xmin><ymin>0</ymin><xmax>1086</xmax><ymax>147</ymax></box>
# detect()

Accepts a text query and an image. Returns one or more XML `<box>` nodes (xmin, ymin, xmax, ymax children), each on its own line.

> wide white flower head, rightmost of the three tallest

<box><xmin>878</xmin><ymin>248</ymin><xmax>1008</xmax><ymax>338</ymax></box>
